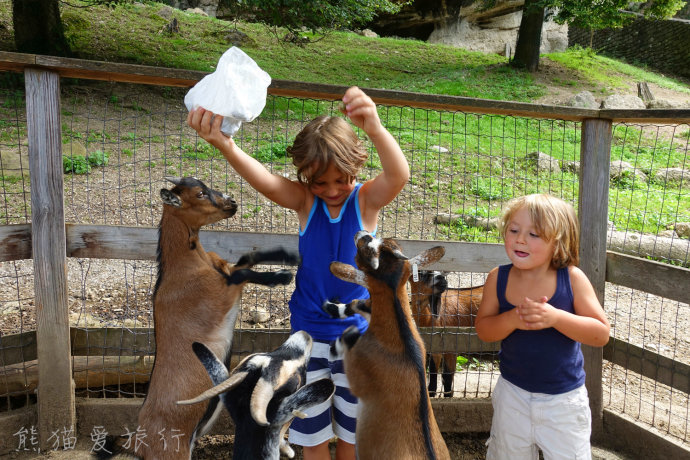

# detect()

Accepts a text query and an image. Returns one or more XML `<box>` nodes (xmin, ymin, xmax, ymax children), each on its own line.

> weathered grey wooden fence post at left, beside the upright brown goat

<box><xmin>25</xmin><ymin>68</ymin><xmax>76</xmax><ymax>449</ymax></box>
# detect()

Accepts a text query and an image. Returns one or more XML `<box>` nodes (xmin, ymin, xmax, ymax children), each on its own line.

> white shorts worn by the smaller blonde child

<box><xmin>486</xmin><ymin>377</ymin><xmax>592</xmax><ymax>460</ymax></box>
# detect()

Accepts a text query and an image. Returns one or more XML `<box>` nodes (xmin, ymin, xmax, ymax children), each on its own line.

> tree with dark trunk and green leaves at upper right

<box><xmin>506</xmin><ymin>0</ymin><xmax>685</xmax><ymax>72</ymax></box>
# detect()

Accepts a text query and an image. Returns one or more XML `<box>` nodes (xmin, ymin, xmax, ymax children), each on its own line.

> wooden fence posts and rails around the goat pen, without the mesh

<box><xmin>0</xmin><ymin>52</ymin><xmax>690</xmax><ymax>458</ymax></box>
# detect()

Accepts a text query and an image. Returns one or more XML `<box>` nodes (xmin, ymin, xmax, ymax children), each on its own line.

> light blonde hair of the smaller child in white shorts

<box><xmin>499</xmin><ymin>193</ymin><xmax>580</xmax><ymax>268</ymax></box>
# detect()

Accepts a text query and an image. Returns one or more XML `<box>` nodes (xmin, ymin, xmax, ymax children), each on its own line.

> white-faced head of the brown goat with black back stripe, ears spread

<box><xmin>330</xmin><ymin>230</ymin><xmax>445</xmax><ymax>289</ymax></box>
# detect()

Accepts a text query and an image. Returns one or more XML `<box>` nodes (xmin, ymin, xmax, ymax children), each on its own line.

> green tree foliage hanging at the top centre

<box><xmin>221</xmin><ymin>0</ymin><xmax>407</xmax><ymax>40</ymax></box>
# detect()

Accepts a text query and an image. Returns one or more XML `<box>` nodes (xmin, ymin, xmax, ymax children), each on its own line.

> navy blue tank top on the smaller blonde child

<box><xmin>496</xmin><ymin>264</ymin><xmax>585</xmax><ymax>394</ymax></box>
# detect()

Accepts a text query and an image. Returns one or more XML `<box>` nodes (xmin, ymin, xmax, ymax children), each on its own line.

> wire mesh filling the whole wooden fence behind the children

<box><xmin>0</xmin><ymin>76</ymin><xmax>690</xmax><ymax>442</ymax></box>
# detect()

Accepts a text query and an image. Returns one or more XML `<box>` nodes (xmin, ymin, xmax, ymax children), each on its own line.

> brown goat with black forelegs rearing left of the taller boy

<box><xmin>101</xmin><ymin>177</ymin><xmax>299</xmax><ymax>460</ymax></box>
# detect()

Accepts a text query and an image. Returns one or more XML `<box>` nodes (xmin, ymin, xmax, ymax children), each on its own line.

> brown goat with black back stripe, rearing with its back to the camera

<box><xmin>323</xmin><ymin>231</ymin><xmax>450</xmax><ymax>460</ymax></box>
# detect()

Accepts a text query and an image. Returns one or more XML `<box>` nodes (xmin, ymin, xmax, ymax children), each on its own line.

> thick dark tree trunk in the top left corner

<box><xmin>12</xmin><ymin>0</ymin><xmax>71</xmax><ymax>56</ymax></box>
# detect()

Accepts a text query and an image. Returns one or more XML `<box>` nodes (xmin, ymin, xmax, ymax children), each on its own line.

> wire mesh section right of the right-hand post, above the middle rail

<box><xmin>607</xmin><ymin>124</ymin><xmax>690</xmax><ymax>266</ymax></box>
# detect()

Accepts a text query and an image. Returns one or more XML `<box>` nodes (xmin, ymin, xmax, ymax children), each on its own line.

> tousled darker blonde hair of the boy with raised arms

<box><xmin>287</xmin><ymin>115</ymin><xmax>368</xmax><ymax>185</ymax></box>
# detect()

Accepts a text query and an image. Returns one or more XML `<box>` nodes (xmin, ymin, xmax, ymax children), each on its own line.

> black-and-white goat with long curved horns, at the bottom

<box><xmin>178</xmin><ymin>331</ymin><xmax>335</xmax><ymax>460</ymax></box>
